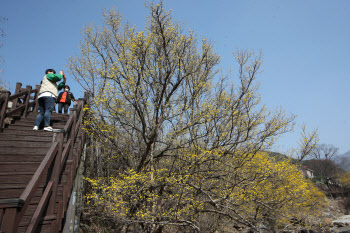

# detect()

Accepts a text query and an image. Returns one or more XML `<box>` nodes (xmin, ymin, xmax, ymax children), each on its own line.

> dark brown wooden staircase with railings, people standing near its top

<box><xmin>0</xmin><ymin>83</ymin><xmax>87</xmax><ymax>233</ymax></box>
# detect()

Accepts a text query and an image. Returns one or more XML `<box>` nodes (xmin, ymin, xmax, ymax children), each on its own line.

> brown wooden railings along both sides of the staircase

<box><xmin>0</xmin><ymin>83</ymin><xmax>90</xmax><ymax>233</ymax></box>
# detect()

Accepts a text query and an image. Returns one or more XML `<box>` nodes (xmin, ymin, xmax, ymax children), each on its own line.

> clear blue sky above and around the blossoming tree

<box><xmin>0</xmin><ymin>0</ymin><xmax>350</xmax><ymax>153</ymax></box>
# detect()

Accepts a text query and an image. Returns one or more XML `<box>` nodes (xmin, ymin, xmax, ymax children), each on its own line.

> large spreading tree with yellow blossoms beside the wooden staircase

<box><xmin>69</xmin><ymin>2</ymin><xmax>324</xmax><ymax>232</ymax></box>
